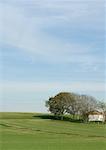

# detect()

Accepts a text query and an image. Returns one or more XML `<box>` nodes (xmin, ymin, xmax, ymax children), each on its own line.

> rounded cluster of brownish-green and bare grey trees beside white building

<box><xmin>46</xmin><ymin>92</ymin><xmax>106</xmax><ymax>120</ymax></box>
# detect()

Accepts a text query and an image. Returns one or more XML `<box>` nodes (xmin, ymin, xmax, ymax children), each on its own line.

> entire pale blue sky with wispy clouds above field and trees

<box><xmin>0</xmin><ymin>0</ymin><xmax>106</xmax><ymax>112</ymax></box>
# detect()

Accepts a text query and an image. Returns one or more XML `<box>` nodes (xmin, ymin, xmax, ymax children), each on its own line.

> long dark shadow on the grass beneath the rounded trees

<box><xmin>33</xmin><ymin>114</ymin><xmax>83</xmax><ymax>123</ymax></box>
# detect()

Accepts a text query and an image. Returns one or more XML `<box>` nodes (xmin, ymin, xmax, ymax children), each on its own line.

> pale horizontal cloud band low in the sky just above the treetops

<box><xmin>0</xmin><ymin>81</ymin><xmax>106</xmax><ymax>92</ymax></box>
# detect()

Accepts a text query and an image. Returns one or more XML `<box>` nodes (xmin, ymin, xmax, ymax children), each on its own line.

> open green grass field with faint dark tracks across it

<box><xmin>0</xmin><ymin>113</ymin><xmax>106</xmax><ymax>150</ymax></box>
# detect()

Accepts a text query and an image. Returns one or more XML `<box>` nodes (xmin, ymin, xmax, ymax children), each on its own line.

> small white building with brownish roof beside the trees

<box><xmin>88</xmin><ymin>111</ymin><xmax>105</xmax><ymax>122</ymax></box>
